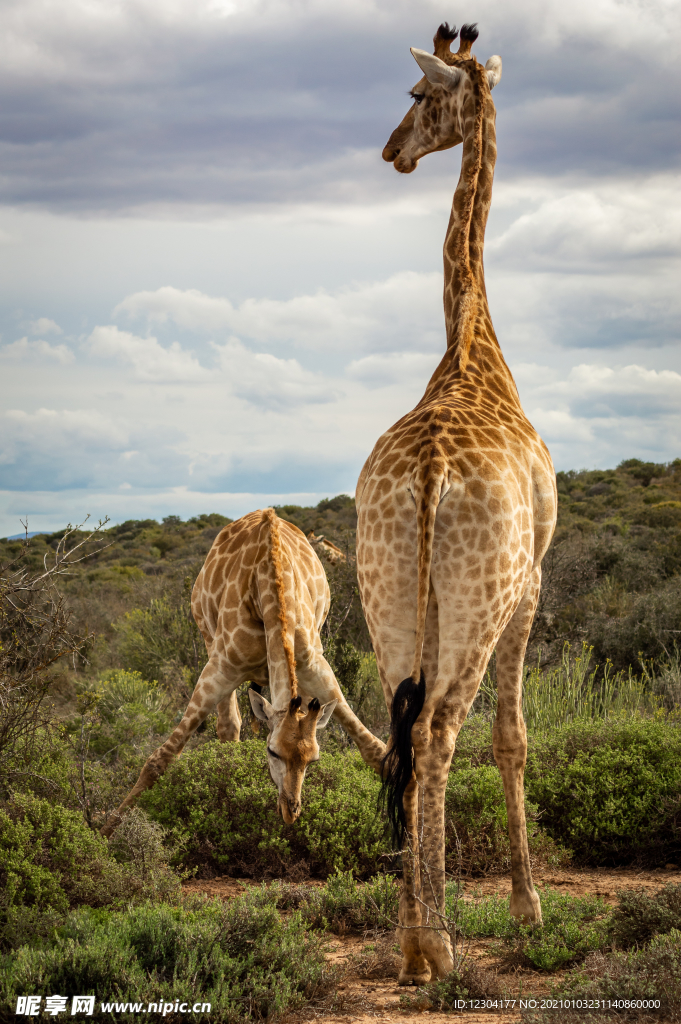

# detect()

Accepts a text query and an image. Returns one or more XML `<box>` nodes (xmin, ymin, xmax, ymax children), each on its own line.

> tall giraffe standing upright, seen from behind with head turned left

<box><xmin>356</xmin><ymin>23</ymin><xmax>556</xmax><ymax>984</ymax></box>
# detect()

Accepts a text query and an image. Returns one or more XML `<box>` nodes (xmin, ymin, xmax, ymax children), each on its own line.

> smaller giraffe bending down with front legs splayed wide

<box><xmin>101</xmin><ymin>509</ymin><xmax>385</xmax><ymax>836</ymax></box>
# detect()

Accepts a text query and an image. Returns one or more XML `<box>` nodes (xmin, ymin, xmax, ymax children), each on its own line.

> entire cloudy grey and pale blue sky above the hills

<box><xmin>0</xmin><ymin>0</ymin><xmax>681</xmax><ymax>536</ymax></box>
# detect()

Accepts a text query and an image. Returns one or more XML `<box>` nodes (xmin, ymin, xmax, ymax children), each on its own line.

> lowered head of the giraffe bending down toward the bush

<box><xmin>248</xmin><ymin>689</ymin><xmax>338</xmax><ymax>824</ymax></box>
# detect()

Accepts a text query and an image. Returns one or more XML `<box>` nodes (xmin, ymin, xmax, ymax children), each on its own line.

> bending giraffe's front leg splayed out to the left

<box><xmin>99</xmin><ymin>655</ymin><xmax>241</xmax><ymax>837</ymax></box>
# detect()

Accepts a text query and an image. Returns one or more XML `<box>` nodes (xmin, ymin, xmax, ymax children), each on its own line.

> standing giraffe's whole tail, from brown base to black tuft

<box><xmin>379</xmin><ymin>444</ymin><xmax>446</xmax><ymax>850</ymax></box>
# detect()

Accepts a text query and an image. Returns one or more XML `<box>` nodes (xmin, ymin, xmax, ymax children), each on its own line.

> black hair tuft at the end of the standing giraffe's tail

<box><xmin>379</xmin><ymin>669</ymin><xmax>426</xmax><ymax>850</ymax></box>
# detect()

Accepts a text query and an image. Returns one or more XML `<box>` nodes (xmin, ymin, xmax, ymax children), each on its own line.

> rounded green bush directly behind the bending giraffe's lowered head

<box><xmin>142</xmin><ymin>740</ymin><xmax>386</xmax><ymax>877</ymax></box>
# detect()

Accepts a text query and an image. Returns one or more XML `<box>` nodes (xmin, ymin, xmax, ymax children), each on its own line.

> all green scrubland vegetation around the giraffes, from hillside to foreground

<box><xmin>0</xmin><ymin>460</ymin><xmax>681</xmax><ymax>1021</ymax></box>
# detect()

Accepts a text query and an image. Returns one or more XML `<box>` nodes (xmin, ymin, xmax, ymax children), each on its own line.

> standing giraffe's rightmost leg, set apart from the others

<box><xmin>493</xmin><ymin>566</ymin><xmax>542</xmax><ymax>924</ymax></box>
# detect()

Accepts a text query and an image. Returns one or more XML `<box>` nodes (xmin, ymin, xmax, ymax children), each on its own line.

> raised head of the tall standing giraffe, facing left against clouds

<box><xmin>383</xmin><ymin>22</ymin><xmax>502</xmax><ymax>174</ymax></box>
